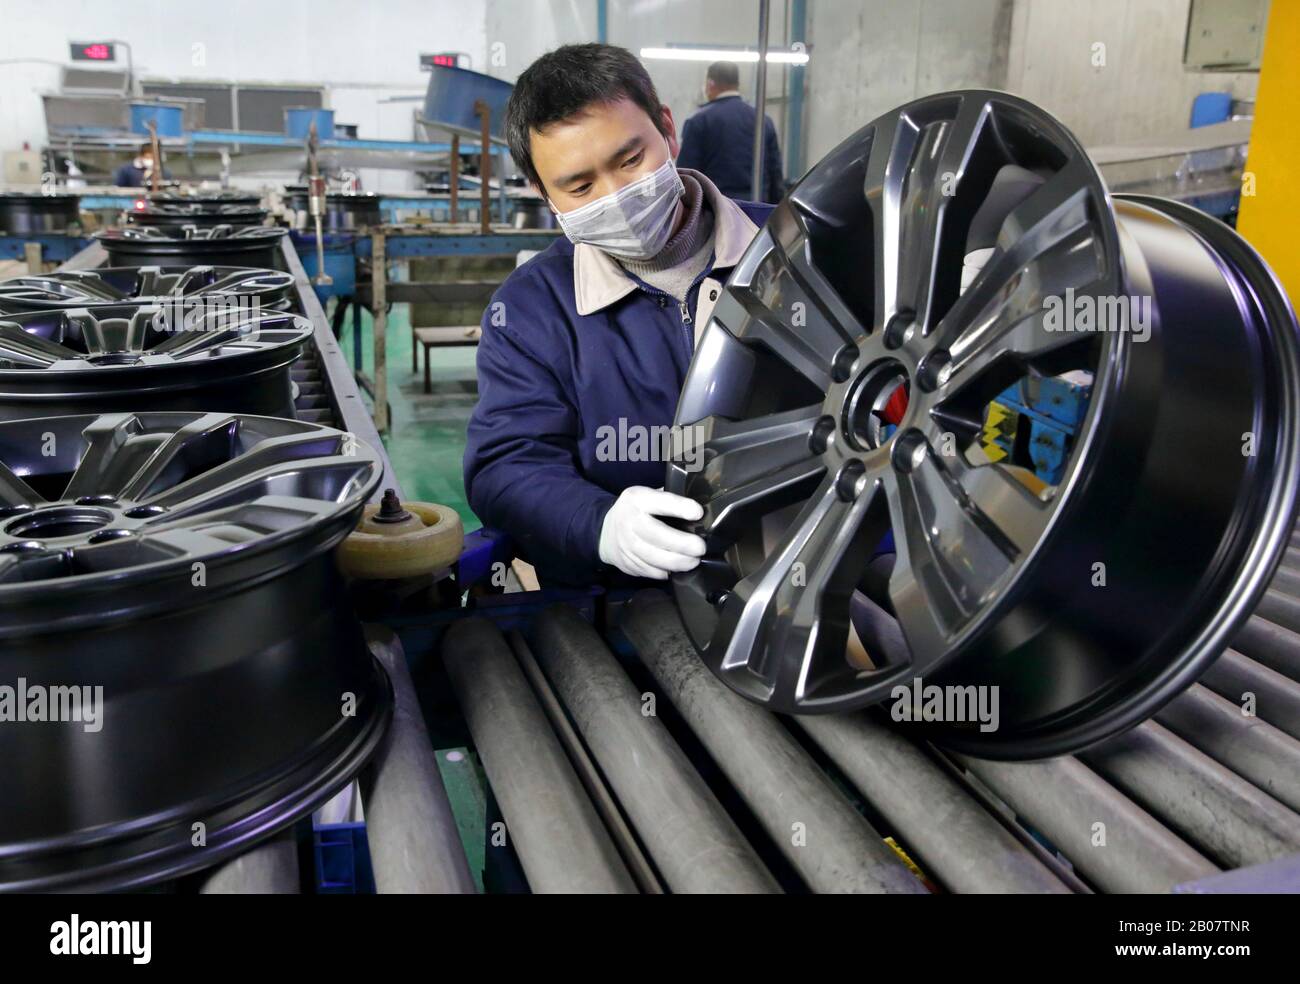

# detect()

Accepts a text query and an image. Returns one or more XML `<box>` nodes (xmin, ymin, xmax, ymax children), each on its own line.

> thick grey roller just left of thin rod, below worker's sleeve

<box><xmin>442</xmin><ymin>617</ymin><xmax>637</xmax><ymax>894</ymax></box>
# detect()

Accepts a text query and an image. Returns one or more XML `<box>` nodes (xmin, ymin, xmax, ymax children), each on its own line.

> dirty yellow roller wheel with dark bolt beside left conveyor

<box><xmin>338</xmin><ymin>489</ymin><xmax>465</xmax><ymax>581</ymax></box>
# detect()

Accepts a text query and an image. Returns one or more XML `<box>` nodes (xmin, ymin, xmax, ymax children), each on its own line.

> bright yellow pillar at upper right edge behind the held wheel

<box><xmin>1236</xmin><ymin>0</ymin><xmax>1300</xmax><ymax>304</ymax></box>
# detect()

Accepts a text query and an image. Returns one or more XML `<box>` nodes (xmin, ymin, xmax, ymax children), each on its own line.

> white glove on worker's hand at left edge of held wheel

<box><xmin>599</xmin><ymin>485</ymin><xmax>705</xmax><ymax>581</ymax></box>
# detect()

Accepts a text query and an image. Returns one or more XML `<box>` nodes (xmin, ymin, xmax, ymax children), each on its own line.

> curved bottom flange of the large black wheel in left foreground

<box><xmin>0</xmin><ymin>655</ymin><xmax>394</xmax><ymax>893</ymax></box>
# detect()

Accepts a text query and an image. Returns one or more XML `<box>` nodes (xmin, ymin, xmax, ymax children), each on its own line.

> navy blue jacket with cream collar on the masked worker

<box><xmin>465</xmin><ymin>175</ymin><xmax>771</xmax><ymax>585</ymax></box>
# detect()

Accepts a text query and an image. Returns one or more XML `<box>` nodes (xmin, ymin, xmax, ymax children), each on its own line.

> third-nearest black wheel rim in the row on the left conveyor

<box><xmin>0</xmin><ymin>265</ymin><xmax>294</xmax><ymax>315</ymax></box>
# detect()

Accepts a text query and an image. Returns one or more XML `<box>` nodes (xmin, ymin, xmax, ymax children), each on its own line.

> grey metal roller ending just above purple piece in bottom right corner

<box><xmin>1082</xmin><ymin>721</ymin><xmax>1300</xmax><ymax>868</ymax></box>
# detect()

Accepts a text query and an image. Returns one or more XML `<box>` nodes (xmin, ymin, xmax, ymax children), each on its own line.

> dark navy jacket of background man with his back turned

<box><xmin>677</xmin><ymin>95</ymin><xmax>785</xmax><ymax>204</ymax></box>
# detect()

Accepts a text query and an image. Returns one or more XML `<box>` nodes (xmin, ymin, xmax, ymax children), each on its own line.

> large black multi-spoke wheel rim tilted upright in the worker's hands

<box><xmin>667</xmin><ymin>92</ymin><xmax>1300</xmax><ymax>758</ymax></box>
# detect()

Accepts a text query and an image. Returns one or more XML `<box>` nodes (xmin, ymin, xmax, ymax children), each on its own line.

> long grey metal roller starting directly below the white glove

<box><xmin>621</xmin><ymin>591</ymin><xmax>926</xmax><ymax>894</ymax></box>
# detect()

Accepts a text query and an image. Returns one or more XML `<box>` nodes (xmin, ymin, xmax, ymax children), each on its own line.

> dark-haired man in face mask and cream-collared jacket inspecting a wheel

<box><xmin>465</xmin><ymin>44</ymin><xmax>771</xmax><ymax>585</ymax></box>
